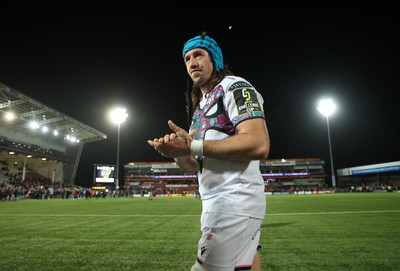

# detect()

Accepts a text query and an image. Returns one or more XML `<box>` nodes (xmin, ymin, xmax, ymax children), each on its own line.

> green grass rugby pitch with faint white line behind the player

<box><xmin>0</xmin><ymin>192</ymin><xmax>400</xmax><ymax>271</ymax></box>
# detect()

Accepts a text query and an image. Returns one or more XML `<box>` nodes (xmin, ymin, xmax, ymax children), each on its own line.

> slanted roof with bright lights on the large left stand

<box><xmin>0</xmin><ymin>83</ymin><xmax>107</xmax><ymax>144</ymax></box>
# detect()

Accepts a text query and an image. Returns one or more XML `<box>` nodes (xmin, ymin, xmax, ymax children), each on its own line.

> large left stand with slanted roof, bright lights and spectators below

<box><xmin>0</xmin><ymin>83</ymin><xmax>107</xmax><ymax>185</ymax></box>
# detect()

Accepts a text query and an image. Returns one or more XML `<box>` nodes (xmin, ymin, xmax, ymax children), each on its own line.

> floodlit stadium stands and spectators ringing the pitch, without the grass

<box><xmin>0</xmin><ymin>79</ymin><xmax>400</xmax><ymax>197</ymax></box>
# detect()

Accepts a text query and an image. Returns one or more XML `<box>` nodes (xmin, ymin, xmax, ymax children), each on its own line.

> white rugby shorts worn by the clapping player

<box><xmin>194</xmin><ymin>213</ymin><xmax>262</xmax><ymax>271</ymax></box>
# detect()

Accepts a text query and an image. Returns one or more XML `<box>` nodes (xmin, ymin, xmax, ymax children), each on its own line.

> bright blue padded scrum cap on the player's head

<box><xmin>182</xmin><ymin>36</ymin><xmax>224</xmax><ymax>72</ymax></box>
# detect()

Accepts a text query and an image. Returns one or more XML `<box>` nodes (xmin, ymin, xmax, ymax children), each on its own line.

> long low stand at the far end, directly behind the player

<box><xmin>124</xmin><ymin>158</ymin><xmax>327</xmax><ymax>195</ymax></box>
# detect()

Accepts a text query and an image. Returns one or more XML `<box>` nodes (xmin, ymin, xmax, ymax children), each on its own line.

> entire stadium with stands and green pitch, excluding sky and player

<box><xmin>0</xmin><ymin>84</ymin><xmax>400</xmax><ymax>271</ymax></box>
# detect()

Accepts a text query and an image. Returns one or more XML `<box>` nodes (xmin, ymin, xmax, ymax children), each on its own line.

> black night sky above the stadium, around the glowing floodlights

<box><xmin>0</xmin><ymin>4</ymin><xmax>400</xmax><ymax>185</ymax></box>
